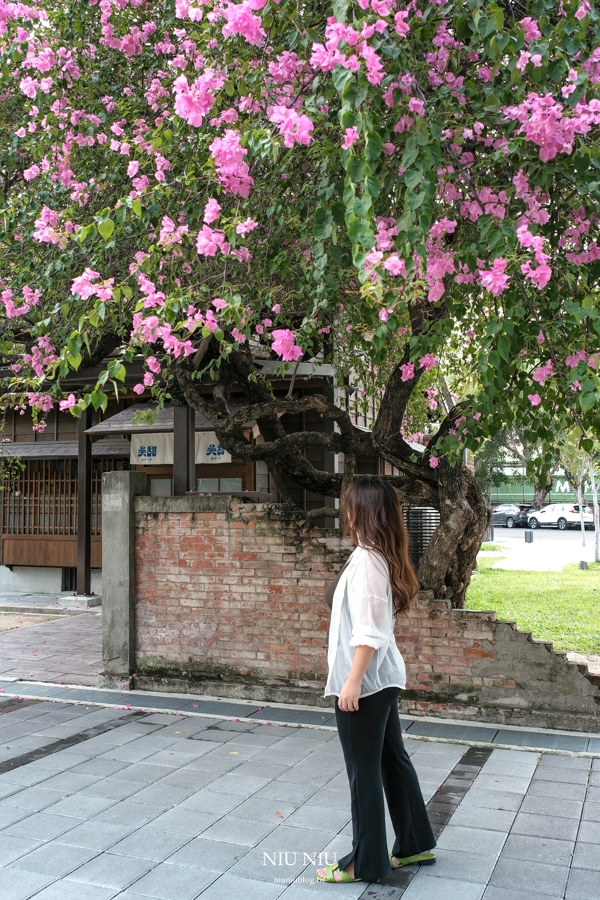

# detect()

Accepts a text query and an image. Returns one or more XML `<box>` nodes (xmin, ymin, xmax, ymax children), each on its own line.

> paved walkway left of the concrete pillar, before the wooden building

<box><xmin>0</xmin><ymin>612</ymin><xmax>103</xmax><ymax>684</ymax></box>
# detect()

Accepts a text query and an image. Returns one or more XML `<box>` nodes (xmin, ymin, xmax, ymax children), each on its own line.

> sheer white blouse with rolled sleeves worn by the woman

<box><xmin>323</xmin><ymin>547</ymin><xmax>406</xmax><ymax>697</ymax></box>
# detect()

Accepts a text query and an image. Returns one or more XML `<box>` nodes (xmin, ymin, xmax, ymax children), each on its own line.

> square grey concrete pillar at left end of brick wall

<box><xmin>97</xmin><ymin>472</ymin><xmax>148</xmax><ymax>689</ymax></box>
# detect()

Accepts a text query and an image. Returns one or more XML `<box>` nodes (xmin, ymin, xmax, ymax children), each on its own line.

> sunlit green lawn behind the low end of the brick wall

<box><xmin>466</xmin><ymin>557</ymin><xmax>600</xmax><ymax>654</ymax></box>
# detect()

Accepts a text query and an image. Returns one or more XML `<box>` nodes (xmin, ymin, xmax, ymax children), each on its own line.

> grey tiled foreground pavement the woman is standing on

<box><xmin>0</xmin><ymin>690</ymin><xmax>600</xmax><ymax>900</ymax></box>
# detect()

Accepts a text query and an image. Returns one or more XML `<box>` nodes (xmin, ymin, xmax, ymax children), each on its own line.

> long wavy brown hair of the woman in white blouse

<box><xmin>344</xmin><ymin>476</ymin><xmax>419</xmax><ymax>615</ymax></box>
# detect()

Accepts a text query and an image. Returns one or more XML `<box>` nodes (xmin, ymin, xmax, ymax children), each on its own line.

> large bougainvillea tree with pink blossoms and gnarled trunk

<box><xmin>0</xmin><ymin>0</ymin><xmax>600</xmax><ymax>604</ymax></box>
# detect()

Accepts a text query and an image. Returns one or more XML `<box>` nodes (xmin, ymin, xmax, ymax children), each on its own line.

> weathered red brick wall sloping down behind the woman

<box><xmin>134</xmin><ymin>496</ymin><xmax>600</xmax><ymax>731</ymax></box>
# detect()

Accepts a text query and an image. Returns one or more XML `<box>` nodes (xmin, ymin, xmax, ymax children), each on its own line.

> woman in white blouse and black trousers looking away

<box><xmin>317</xmin><ymin>477</ymin><xmax>435</xmax><ymax>882</ymax></box>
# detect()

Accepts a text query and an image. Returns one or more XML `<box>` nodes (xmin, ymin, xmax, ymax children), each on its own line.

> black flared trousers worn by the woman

<box><xmin>335</xmin><ymin>687</ymin><xmax>435</xmax><ymax>881</ymax></box>
